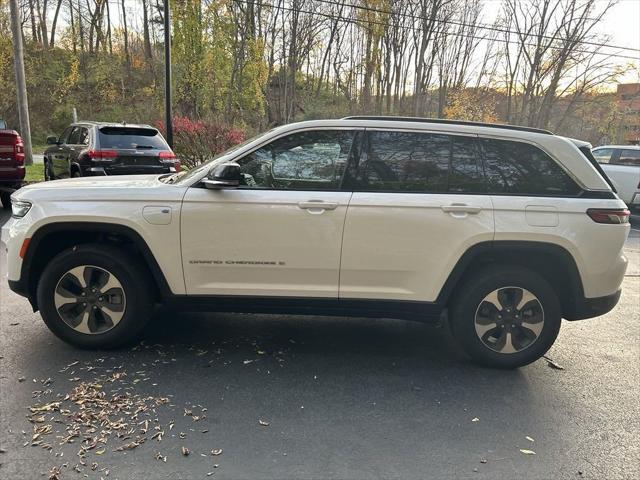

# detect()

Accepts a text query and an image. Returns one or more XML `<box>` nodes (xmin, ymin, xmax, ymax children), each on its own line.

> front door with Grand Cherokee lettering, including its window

<box><xmin>181</xmin><ymin>130</ymin><xmax>358</xmax><ymax>298</ymax></box>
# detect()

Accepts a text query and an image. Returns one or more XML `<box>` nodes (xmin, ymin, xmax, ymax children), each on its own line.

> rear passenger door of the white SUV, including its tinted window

<box><xmin>340</xmin><ymin>130</ymin><xmax>494</xmax><ymax>302</ymax></box>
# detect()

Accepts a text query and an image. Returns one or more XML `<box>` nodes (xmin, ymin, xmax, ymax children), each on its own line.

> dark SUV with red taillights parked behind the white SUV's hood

<box><xmin>44</xmin><ymin>122</ymin><xmax>180</xmax><ymax>180</ymax></box>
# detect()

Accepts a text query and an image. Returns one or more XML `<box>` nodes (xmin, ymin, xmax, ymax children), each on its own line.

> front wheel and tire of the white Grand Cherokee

<box><xmin>37</xmin><ymin>244</ymin><xmax>154</xmax><ymax>348</ymax></box>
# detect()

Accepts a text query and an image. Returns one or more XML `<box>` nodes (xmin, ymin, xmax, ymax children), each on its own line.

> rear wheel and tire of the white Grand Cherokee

<box><xmin>450</xmin><ymin>266</ymin><xmax>562</xmax><ymax>369</ymax></box>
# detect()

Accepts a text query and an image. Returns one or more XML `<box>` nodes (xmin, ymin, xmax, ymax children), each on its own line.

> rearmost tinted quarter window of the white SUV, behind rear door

<box><xmin>480</xmin><ymin>139</ymin><xmax>580</xmax><ymax>196</ymax></box>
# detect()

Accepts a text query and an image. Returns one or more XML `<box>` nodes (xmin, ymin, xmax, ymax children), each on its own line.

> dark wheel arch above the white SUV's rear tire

<box><xmin>437</xmin><ymin>240</ymin><xmax>584</xmax><ymax>318</ymax></box>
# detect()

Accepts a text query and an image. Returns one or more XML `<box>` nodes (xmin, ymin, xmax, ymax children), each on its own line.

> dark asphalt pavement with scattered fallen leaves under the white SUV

<box><xmin>0</xmin><ymin>214</ymin><xmax>640</xmax><ymax>480</ymax></box>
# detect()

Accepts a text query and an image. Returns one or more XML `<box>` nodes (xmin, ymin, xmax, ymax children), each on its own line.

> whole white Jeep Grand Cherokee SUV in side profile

<box><xmin>2</xmin><ymin>117</ymin><xmax>629</xmax><ymax>368</ymax></box>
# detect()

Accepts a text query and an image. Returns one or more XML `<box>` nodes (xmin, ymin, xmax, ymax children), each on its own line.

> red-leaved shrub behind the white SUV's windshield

<box><xmin>155</xmin><ymin>116</ymin><xmax>245</xmax><ymax>168</ymax></box>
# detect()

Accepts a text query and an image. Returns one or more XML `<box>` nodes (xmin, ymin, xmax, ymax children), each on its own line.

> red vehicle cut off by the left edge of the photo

<box><xmin>0</xmin><ymin>129</ymin><xmax>24</xmax><ymax>208</ymax></box>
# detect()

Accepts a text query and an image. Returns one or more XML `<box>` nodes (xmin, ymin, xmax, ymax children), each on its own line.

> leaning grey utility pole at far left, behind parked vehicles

<box><xmin>9</xmin><ymin>0</ymin><xmax>33</xmax><ymax>165</ymax></box>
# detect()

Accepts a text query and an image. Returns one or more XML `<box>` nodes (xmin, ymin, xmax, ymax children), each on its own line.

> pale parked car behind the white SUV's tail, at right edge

<box><xmin>591</xmin><ymin>145</ymin><xmax>640</xmax><ymax>210</ymax></box>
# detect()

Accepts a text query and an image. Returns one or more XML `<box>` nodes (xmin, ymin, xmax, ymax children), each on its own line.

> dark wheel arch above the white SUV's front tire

<box><xmin>20</xmin><ymin>222</ymin><xmax>171</xmax><ymax>311</ymax></box>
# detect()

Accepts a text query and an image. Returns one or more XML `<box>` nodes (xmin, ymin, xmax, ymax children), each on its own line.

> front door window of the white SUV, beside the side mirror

<box><xmin>238</xmin><ymin>130</ymin><xmax>355</xmax><ymax>190</ymax></box>
